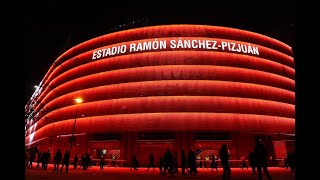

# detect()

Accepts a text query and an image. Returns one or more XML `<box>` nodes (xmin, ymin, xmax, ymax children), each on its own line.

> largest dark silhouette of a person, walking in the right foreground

<box><xmin>254</xmin><ymin>139</ymin><xmax>272</xmax><ymax>180</ymax></box>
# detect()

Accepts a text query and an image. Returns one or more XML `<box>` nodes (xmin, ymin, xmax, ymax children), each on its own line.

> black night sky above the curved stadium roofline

<box><xmin>24</xmin><ymin>0</ymin><xmax>296</xmax><ymax>102</ymax></box>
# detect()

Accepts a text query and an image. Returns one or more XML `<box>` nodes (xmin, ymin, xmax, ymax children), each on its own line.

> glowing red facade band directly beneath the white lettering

<box><xmin>35</xmin><ymin>51</ymin><xmax>294</xmax><ymax>110</ymax></box>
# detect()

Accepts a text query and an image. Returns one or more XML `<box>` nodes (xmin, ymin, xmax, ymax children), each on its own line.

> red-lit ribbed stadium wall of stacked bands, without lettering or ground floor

<box><xmin>25</xmin><ymin>25</ymin><xmax>295</xmax><ymax>144</ymax></box>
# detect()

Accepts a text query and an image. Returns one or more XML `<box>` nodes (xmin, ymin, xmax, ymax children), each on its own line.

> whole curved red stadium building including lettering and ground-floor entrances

<box><xmin>25</xmin><ymin>25</ymin><xmax>295</xmax><ymax>166</ymax></box>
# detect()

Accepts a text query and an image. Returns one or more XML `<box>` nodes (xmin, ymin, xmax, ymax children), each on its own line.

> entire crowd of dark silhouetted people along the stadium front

<box><xmin>25</xmin><ymin>139</ymin><xmax>295</xmax><ymax>180</ymax></box>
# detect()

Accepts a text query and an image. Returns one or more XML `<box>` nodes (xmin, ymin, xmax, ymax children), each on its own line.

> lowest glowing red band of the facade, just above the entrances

<box><xmin>26</xmin><ymin>113</ymin><xmax>295</xmax><ymax>143</ymax></box>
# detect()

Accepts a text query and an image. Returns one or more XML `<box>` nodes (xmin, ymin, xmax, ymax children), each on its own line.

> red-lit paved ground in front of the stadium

<box><xmin>25</xmin><ymin>164</ymin><xmax>295</xmax><ymax>180</ymax></box>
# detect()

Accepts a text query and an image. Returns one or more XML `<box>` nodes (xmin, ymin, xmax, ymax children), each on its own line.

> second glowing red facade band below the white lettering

<box><xmin>35</xmin><ymin>65</ymin><xmax>295</xmax><ymax>116</ymax></box>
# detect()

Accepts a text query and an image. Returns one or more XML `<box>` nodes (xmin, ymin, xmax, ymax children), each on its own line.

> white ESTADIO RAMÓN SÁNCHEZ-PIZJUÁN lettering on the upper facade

<box><xmin>92</xmin><ymin>38</ymin><xmax>259</xmax><ymax>60</ymax></box>
